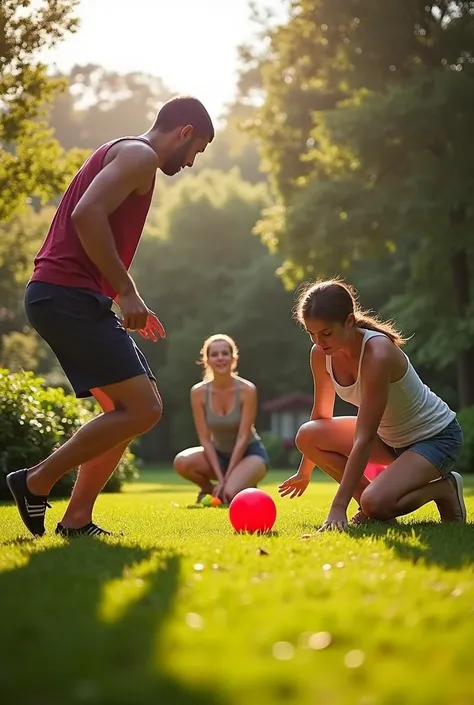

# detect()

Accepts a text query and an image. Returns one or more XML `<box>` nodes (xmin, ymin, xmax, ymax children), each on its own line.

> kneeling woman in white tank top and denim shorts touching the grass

<box><xmin>280</xmin><ymin>280</ymin><xmax>466</xmax><ymax>530</ymax></box>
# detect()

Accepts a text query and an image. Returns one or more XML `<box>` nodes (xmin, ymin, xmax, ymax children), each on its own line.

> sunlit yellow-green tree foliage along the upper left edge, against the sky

<box><xmin>0</xmin><ymin>0</ymin><xmax>83</xmax><ymax>222</ymax></box>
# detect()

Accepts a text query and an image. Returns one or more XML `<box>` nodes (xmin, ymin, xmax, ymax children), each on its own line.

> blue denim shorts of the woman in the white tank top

<box><xmin>388</xmin><ymin>419</ymin><xmax>463</xmax><ymax>476</ymax></box>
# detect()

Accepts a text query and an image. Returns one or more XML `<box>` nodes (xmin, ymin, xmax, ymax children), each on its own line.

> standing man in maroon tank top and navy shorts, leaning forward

<box><xmin>7</xmin><ymin>97</ymin><xmax>214</xmax><ymax>537</ymax></box>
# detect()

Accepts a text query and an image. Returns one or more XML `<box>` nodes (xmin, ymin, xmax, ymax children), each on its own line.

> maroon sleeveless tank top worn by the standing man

<box><xmin>30</xmin><ymin>137</ymin><xmax>155</xmax><ymax>298</ymax></box>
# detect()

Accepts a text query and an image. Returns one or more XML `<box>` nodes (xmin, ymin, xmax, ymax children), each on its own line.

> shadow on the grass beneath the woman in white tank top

<box><xmin>350</xmin><ymin>521</ymin><xmax>474</xmax><ymax>570</ymax></box>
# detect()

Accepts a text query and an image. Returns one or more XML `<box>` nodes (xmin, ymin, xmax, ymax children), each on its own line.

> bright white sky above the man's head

<box><xmin>41</xmin><ymin>0</ymin><xmax>285</xmax><ymax>120</ymax></box>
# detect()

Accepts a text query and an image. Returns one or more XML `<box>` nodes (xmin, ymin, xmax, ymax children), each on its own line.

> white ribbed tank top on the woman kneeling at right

<box><xmin>326</xmin><ymin>329</ymin><xmax>456</xmax><ymax>448</ymax></box>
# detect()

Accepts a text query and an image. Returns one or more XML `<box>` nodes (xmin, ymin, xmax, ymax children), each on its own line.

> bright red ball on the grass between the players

<box><xmin>229</xmin><ymin>487</ymin><xmax>276</xmax><ymax>534</ymax></box>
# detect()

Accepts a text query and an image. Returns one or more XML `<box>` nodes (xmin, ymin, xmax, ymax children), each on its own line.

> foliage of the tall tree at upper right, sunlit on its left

<box><xmin>244</xmin><ymin>0</ymin><xmax>474</xmax><ymax>280</ymax></box>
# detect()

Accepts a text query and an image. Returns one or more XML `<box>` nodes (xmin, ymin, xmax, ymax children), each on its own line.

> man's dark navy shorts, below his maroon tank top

<box><xmin>25</xmin><ymin>281</ymin><xmax>156</xmax><ymax>397</ymax></box>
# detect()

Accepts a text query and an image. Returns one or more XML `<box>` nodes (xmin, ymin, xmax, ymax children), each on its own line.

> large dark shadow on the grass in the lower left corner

<box><xmin>0</xmin><ymin>539</ymin><xmax>224</xmax><ymax>705</ymax></box>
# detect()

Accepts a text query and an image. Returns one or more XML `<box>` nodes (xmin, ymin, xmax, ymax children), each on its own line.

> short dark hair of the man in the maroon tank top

<box><xmin>154</xmin><ymin>96</ymin><xmax>214</xmax><ymax>142</ymax></box>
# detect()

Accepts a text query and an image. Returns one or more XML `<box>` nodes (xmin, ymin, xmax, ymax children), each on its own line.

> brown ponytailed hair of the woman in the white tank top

<box><xmin>294</xmin><ymin>279</ymin><xmax>407</xmax><ymax>346</ymax></box>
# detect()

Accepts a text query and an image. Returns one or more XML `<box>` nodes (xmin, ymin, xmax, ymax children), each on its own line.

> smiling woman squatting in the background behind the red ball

<box><xmin>174</xmin><ymin>335</ymin><xmax>268</xmax><ymax>502</ymax></box>
